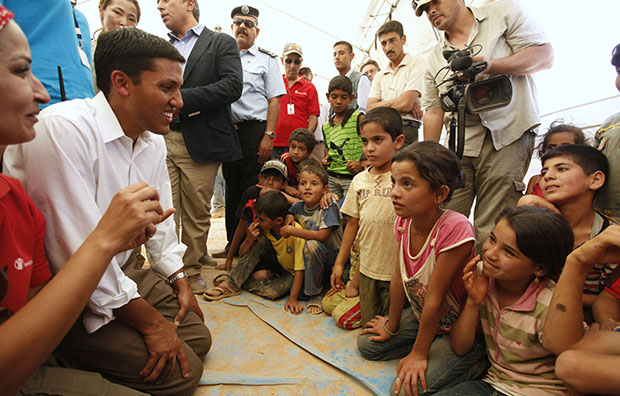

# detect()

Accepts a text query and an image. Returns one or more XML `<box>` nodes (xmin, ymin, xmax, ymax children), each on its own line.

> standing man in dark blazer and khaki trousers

<box><xmin>157</xmin><ymin>0</ymin><xmax>243</xmax><ymax>294</ymax></box>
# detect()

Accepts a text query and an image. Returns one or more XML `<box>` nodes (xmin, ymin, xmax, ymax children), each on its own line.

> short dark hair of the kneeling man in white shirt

<box><xmin>95</xmin><ymin>28</ymin><xmax>185</xmax><ymax>95</ymax></box>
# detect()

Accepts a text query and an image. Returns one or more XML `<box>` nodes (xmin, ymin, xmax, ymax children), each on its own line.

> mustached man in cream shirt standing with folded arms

<box><xmin>368</xmin><ymin>21</ymin><xmax>424</xmax><ymax>144</ymax></box>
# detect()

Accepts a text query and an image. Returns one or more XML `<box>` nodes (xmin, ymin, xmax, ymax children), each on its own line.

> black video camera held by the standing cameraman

<box><xmin>435</xmin><ymin>45</ymin><xmax>512</xmax><ymax>158</ymax></box>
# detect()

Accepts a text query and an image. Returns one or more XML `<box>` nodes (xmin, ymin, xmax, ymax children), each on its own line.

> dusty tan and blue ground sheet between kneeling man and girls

<box><xmin>197</xmin><ymin>292</ymin><xmax>398</xmax><ymax>395</ymax></box>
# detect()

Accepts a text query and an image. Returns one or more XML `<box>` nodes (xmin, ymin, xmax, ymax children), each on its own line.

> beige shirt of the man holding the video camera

<box><xmin>422</xmin><ymin>0</ymin><xmax>549</xmax><ymax>157</ymax></box>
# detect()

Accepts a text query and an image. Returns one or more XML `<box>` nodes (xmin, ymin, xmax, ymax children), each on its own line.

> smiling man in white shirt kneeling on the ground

<box><xmin>5</xmin><ymin>29</ymin><xmax>211</xmax><ymax>395</ymax></box>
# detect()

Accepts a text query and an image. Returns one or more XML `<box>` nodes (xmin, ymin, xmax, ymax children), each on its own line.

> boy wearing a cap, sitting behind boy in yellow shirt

<box><xmin>215</xmin><ymin>160</ymin><xmax>299</xmax><ymax>271</ymax></box>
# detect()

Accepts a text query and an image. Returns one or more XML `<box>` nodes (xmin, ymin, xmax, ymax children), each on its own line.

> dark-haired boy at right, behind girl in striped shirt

<box><xmin>517</xmin><ymin>144</ymin><xmax>616</xmax><ymax>314</ymax></box>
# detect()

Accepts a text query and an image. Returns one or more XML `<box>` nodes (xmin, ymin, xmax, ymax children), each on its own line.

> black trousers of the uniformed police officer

<box><xmin>222</xmin><ymin>121</ymin><xmax>266</xmax><ymax>243</ymax></box>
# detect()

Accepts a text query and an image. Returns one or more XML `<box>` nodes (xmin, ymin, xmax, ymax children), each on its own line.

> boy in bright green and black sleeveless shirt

<box><xmin>323</xmin><ymin>76</ymin><xmax>364</xmax><ymax>199</ymax></box>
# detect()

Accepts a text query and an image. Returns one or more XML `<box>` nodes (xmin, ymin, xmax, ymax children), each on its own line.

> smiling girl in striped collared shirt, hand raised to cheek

<box><xmin>436</xmin><ymin>206</ymin><xmax>573</xmax><ymax>396</ymax></box>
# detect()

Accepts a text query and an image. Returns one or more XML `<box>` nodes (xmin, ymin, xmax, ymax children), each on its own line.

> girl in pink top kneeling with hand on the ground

<box><xmin>358</xmin><ymin>142</ymin><xmax>485</xmax><ymax>394</ymax></box>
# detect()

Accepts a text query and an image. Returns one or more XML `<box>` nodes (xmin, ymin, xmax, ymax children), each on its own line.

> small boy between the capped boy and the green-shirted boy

<box><xmin>280</xmin><ymin>128</ymin><xmax>316</xmax><ymax>198</ymax></box>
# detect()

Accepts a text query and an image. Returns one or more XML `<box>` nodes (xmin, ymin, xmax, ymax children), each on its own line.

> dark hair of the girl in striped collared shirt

<box><xmin>495</xmin><ymin>206</ymin><xmax>574</xmax><ymax>281</ymax></box>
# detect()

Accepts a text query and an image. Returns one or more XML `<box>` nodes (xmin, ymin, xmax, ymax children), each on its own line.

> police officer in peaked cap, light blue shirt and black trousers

<box><xmin>214</xmin><ymin>5</ymin><xmax>286</xmax><ymax>257</ymax></box>
